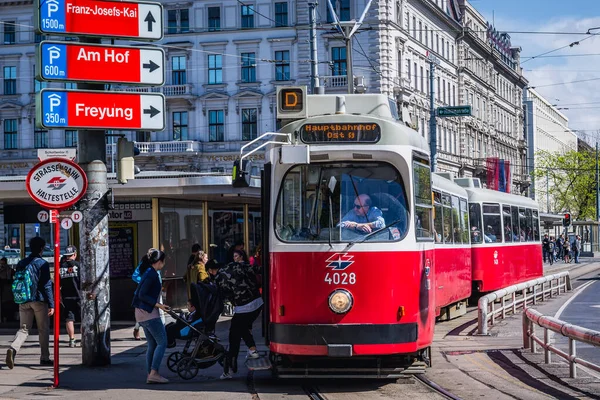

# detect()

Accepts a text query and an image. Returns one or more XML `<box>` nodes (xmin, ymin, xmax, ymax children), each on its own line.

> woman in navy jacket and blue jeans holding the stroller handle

<box><xmin>131</xmin><ymin>250</ymin><xmax>169</xmax><ymax>383</ymax></box>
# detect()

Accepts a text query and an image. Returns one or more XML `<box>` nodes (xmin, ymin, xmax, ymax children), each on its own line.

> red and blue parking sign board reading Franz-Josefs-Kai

<box><xmin>33</xmin><ymin>0</ymin><xmax>163</xmax><ymax>40</ymax></box>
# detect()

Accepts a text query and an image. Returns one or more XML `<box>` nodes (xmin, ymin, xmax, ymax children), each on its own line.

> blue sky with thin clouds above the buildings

<box><xmin>470</xmin><ymin>0</ymin><xmax>600</xmax><ymax>143</ymax></box>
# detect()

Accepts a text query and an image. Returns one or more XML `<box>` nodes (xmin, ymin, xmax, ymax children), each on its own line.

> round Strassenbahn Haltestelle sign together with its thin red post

<box><xmin>25</xmin><ymin>158</ymin><xmax>87</xmax><ymax>387</ymax></box>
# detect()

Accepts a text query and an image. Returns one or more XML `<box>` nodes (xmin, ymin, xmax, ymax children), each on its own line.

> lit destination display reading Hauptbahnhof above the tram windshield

<box><xmin>300</xmin><ymin>122</ymin><xmax>381</xmax><ymax>143</ymax></box>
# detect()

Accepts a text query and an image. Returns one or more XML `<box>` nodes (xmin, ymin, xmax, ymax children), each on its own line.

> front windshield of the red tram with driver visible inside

<box><xmin>275</xmin><ymin>163</ymin><xmax>409</xmax><ymax>243</ymax></box>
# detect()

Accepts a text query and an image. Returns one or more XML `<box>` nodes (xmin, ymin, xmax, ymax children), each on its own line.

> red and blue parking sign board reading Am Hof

<box><xmin>35</xmin><ymin>41</ymin><xmax>165</xmax><ymax>86</ymax></box>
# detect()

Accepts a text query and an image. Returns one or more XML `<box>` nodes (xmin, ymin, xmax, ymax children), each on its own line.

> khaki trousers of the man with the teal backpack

<box><xmin>10</xmin><ymin>301</ymin><xmax>50</xmax><ymax>361</ymax></box>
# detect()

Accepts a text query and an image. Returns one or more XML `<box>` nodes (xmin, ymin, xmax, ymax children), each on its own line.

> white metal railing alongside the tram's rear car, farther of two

<box><xmin>477</xmin><ymin>271</ymin><xmax>571</xmax><ymax>335</ymax></box>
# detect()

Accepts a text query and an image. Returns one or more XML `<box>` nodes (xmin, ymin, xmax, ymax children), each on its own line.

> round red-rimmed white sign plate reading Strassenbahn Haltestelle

<box><xmin>25</xmin><ymin>158</ymin><xmax>87</xmax><ymax>210</ymax></box>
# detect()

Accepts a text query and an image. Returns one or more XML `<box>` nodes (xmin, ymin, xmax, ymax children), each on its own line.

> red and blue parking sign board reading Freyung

<box><xmin>35</xmin><ymin>89</ymin><xmax>165</xmax><ymax>131</ymax></box>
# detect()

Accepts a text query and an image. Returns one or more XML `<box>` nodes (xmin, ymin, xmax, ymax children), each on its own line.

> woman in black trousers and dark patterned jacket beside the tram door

<box><xmin>216</xmin><ymin>250</ymin><xmax>263</xmax><ymax>379</ymax></box>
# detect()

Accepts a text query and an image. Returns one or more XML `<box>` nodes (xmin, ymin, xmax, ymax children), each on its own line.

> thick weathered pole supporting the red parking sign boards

<box><xmin>78</xmin><ymin>38</ymin><xmax>110</xmax><ymax>366</ymax></box>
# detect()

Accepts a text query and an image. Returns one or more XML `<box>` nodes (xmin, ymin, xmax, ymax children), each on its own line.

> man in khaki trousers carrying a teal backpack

<box><xmin>6</xmin><ymin>237</ymin><xmax>54</xmax><ymax>369</ymax></box>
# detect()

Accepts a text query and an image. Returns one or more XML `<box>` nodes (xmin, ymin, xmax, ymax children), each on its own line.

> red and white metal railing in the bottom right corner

<box><xmin>523</xmin><ymin>308</ymin><xmax>600</xmax><ymax>378</ymax></box>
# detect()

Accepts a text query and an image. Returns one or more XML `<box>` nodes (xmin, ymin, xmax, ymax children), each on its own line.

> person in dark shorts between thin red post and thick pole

<box><xmin>59</xmin><ymin>246</ymin><xmax>81</xmax><ymax>347</ymax></box>
